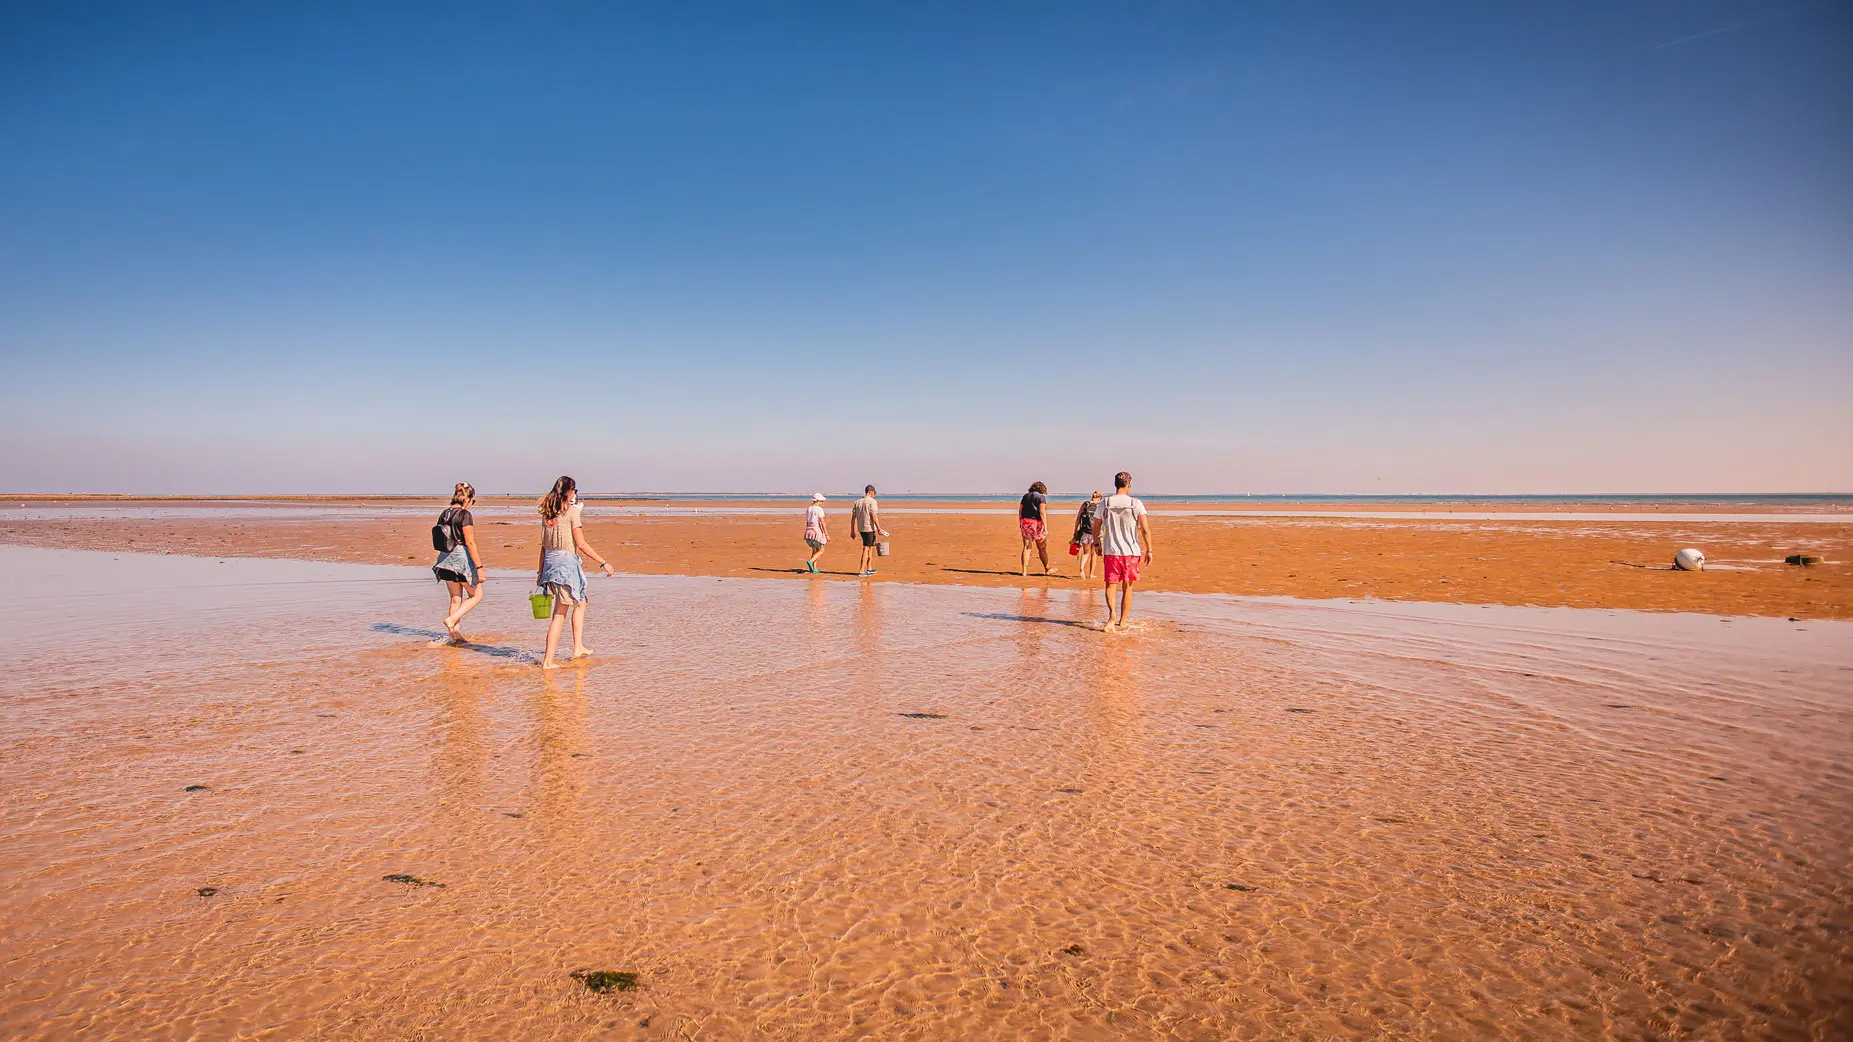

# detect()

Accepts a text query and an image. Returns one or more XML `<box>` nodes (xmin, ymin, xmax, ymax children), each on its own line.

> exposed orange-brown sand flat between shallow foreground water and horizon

<box><xmin>0</xmin><ymin>499</ymin><xmax>1853</xmax><ymax>619</ymax></box>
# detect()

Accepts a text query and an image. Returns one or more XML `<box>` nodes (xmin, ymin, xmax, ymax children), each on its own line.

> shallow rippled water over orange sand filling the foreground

<box><xmin>0</xmin><ymin>547</ymin><xmax>1853</xmax><ymax>1040</ymax></box>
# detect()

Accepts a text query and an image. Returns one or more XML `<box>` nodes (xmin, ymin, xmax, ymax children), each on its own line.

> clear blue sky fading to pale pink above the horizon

<box><xmin>0</xmin><ymin>0</ymin><xmax>1853</xmax><ymax>493</ymax></box>
